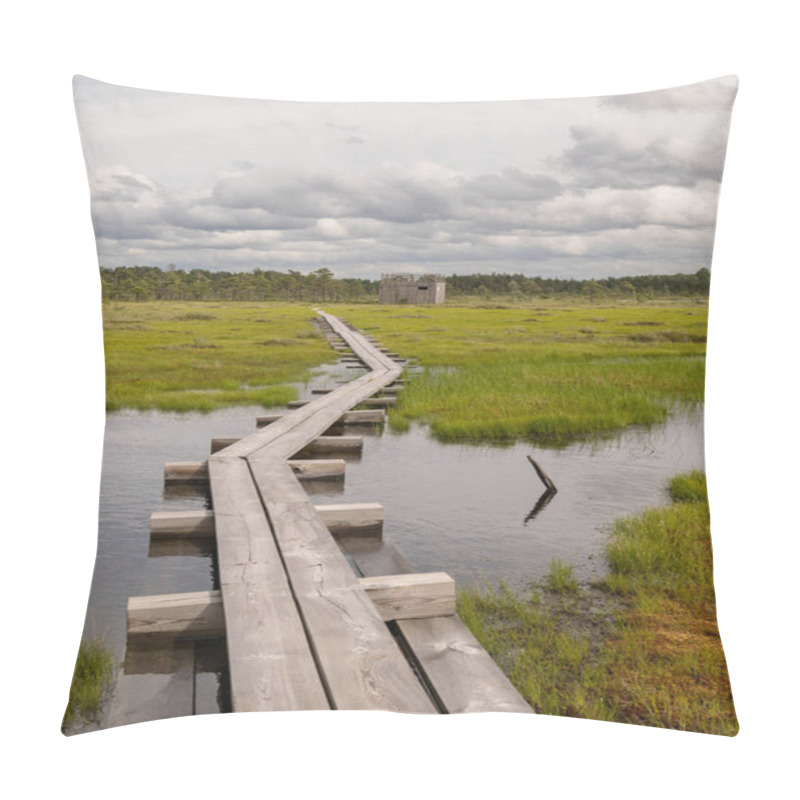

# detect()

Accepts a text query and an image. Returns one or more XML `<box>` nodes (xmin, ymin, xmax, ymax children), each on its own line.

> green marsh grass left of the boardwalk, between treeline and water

<box><xmin>103</xmin><ymin>302</ymin><xmax>331</xmax><ymax>411</ymax></box>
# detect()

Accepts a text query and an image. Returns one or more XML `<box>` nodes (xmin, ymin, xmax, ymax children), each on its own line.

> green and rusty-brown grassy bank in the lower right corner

<box><xmin>458</xmin><ymin>473</ymin><xmax>738</xmax><ymax>736</ymax></box>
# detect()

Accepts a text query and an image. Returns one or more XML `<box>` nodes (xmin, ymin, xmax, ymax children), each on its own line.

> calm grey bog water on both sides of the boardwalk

<box><xmin>76</xmin><ymin>366</ymin><xmax>704</xmax><ymax>726</ymax></box>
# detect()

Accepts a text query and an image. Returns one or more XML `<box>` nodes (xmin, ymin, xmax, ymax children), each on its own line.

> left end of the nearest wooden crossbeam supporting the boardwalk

<box><xmin>127</xmin><ymin>591</ymin><xmax>224</xmax><ymax>638</ymax></box>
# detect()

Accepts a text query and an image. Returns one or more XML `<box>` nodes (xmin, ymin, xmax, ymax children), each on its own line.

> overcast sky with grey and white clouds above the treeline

<box><xmin>75</xmin><ymin>77</ymin><xmax>736</xmax><ymax>278</ymax></box>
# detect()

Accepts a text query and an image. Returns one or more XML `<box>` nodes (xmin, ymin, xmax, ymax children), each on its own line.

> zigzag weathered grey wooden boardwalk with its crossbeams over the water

<box><xmin>128</xmin><ymin>312</ymin><xmax>531</xmax><ymax>713</ymax></box>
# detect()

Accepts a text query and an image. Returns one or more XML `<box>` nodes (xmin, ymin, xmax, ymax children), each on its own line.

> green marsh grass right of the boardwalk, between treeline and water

<box><xmin>330</xmin><ymin>303</ymin><xmax>707</xmax><ymax>446</ymax></box>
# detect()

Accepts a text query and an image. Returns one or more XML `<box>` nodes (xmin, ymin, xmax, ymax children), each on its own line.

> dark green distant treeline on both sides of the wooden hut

<box><xmin>100</xmin><ymin>267</ymin><xmax>711</xmax><ymax>303</ymax></box>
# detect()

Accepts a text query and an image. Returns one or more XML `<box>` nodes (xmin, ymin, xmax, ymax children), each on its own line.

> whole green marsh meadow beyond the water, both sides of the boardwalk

<box><xmin>103</xmin><ymin>302</ymin><xmax>707</xmax><ymax>454</ymax></box>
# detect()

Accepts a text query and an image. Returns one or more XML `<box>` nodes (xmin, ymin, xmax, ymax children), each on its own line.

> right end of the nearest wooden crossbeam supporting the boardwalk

<box><xmin>359</xmin><ymin>572</ymin><xmax>456</xmax><ymax>622</ymax></box>
